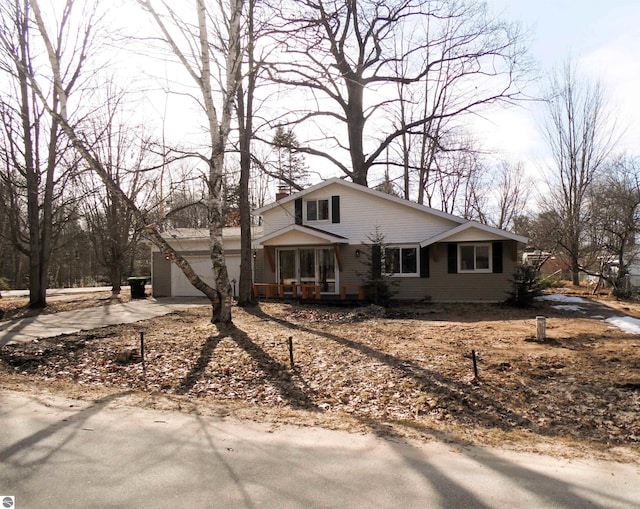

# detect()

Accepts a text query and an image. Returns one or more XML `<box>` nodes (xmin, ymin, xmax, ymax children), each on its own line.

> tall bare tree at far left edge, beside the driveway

<box><xmin>0</xmin><ymin>0</ymin><xmax>96</xmax><ymax>308</ymax></box>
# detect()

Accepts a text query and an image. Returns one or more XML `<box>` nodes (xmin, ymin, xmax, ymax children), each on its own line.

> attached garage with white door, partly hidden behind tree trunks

<box><xmin>151</xmin><ymin>228</ymin><xmax>261</xmax><ymax>297</ymax></box>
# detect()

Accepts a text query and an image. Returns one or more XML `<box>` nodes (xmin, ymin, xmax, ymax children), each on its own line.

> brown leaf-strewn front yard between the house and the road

<box><xmin>0</xmin><ymin>290</ymin><xmax>640</xmax><ymax>461</ymax></box>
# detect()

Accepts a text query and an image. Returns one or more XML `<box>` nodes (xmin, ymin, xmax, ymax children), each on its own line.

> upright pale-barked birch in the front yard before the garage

<box><xmin>138</xmin><ymin>0</ymin><xmax>243</xmax><ymax>322</ymax></box>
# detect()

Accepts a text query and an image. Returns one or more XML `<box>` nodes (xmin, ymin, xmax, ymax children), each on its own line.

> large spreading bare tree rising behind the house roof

<box><xmin>262</xmin><ymin>0</ymin><xmax>526</xmax><ymax>185</ymax></box>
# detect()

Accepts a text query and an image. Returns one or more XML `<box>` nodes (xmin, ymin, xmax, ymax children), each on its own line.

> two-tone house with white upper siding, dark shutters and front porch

<box><xmin>254</xmin><ymin>179</ymin><xmax>528</xmax><ymax>302</ymax></box>
